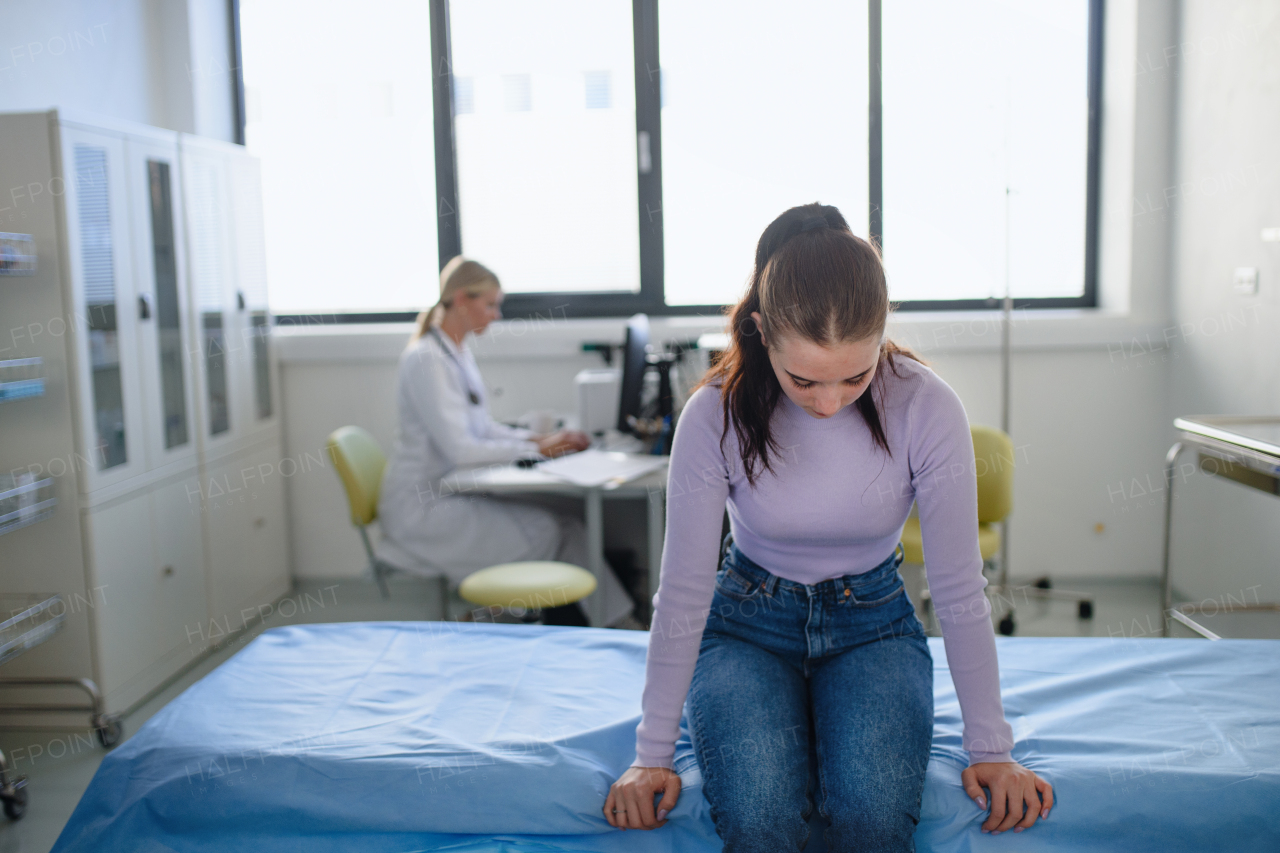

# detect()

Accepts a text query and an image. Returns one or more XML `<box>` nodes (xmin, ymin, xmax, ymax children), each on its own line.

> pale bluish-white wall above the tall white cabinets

<box><xmin>0</xmin><ymin>0</ymin><xmax>236</xmax><ymax>141</ymax></box>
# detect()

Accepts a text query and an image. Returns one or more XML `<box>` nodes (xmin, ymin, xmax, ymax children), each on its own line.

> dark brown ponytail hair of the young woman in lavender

<box><xmin>698</xmin><ymin>202</ymin><xmax>920</xmax><ymax>485</ymax></box>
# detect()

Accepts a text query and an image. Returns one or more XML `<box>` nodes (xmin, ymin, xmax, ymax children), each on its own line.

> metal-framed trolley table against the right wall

<box><xmin>1161</xmin><ymin>415</ymin><xmax>1280</xmax><ymax>639</ymax></box>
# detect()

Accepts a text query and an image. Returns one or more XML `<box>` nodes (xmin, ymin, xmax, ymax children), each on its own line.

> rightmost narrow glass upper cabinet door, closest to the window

<box><xmin>229</xmin><ymin>155</ymin><xmax>279</xmax><ymax>434</ymax></box>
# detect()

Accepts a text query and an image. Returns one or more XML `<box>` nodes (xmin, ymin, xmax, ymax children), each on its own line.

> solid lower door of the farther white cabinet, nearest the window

<box><xmin>201</xmin><ymin>443</ymin><xmax>297</xmax><ymax>630</ymax></box>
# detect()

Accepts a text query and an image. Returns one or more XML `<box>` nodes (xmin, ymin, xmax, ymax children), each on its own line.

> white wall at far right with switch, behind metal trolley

<box><xmin>1167</xmin><ymin>0</ymin><xmax>1280</xmax><ymax>601</ymax></box>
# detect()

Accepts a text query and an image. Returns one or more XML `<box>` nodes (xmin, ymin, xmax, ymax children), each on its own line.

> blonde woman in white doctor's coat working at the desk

<box><xmin>378</xmin><ymin>255</ymin><xmax>634</xmax><ymax>625</ymax></box>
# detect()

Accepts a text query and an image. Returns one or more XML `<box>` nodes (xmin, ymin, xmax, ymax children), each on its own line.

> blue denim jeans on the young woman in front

<box><xmin>689</xmin><ymin>546</ymin><xmax>933</xmax><ymax>853</ymax></box>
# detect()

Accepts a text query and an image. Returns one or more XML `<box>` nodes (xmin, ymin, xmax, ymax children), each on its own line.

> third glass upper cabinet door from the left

<box><xmin>182</xmin><ymin>145</ymin><xmax>246</xmax><ymax>452</ymax></box>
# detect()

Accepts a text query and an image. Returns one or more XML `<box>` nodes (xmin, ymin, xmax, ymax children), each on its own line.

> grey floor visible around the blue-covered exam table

<box><xmin>0</xmin><ymin>565</ymin><xmax>1280</xmax><ymax>853</ymax></box>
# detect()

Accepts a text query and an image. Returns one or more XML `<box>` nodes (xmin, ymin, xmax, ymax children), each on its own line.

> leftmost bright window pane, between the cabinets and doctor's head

<box><xmin>239</xmin><ymin>0</ymin><xmax>440</xmax><ymax>316</ymax></box>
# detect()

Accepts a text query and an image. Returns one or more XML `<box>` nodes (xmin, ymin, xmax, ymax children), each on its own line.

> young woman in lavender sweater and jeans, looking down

<box><xmin>603</xmin><ymin>204</ymin><xmax>1053</xmax><ymax>853</ymax></box>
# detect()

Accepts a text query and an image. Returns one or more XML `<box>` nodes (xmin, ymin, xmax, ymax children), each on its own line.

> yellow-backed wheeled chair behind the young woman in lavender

<box><xmin>902</xmin><ymin>427</ymin><xmax>1093</xmax><ymax>637</ymax></box>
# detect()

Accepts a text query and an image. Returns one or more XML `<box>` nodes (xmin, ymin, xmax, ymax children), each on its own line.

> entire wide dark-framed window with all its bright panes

<box><xmin>249</xmin><ymin>0</ymin><xmax>1102</xmax><ymax>319</ymax></box>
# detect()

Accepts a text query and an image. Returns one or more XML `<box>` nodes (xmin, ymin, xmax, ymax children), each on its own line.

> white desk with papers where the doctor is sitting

<box><xmin>443</xmin><ymin>465</ymin><xmax>667</xmax><ymax>628</ymax></box>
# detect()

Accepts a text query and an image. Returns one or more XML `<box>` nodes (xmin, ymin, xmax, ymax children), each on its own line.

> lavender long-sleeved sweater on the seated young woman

<box><xmin>634</xmin><ymin>357</ymin><xmax>1014</xmax><ymax>767</ymax></box>
